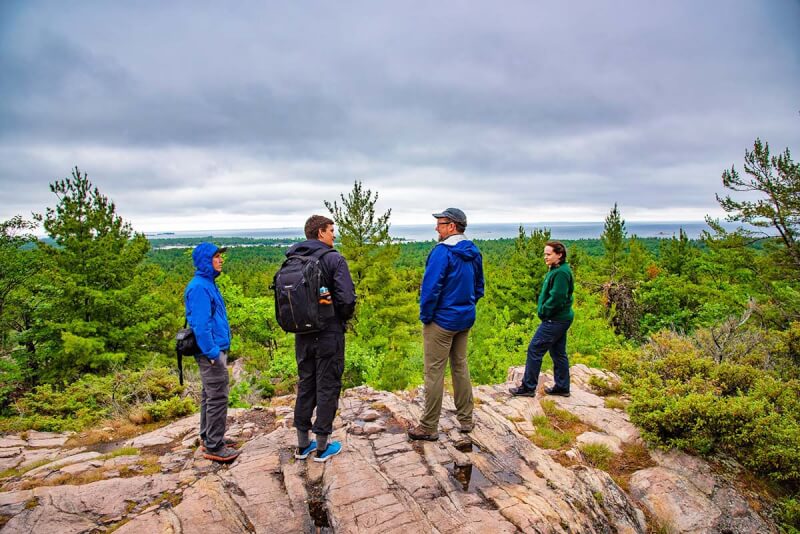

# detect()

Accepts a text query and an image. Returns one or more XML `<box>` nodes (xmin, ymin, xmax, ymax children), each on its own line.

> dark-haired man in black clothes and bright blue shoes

<box><xmin>282</xmin><ymin>215</ymin><xmax>356</xmax><ymax>462</ymax></box>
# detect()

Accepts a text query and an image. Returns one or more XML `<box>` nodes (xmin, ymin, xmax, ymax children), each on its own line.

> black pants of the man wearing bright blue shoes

<box><xmin>294</xmin><ymin>330</ymin><xmax>344</xmax><ymax>435</ymax></box>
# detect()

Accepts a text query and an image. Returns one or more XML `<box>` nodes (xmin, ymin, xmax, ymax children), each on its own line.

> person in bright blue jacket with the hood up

<box><xmin>183</xmin><ymin>243</ymin><xmax>239</xmax><ymax>462</ymax></box>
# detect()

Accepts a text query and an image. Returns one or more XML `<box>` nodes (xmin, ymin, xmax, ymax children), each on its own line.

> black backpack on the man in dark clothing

<box><xmin>272</xmin><ymin>249</ymin><xmax>335</xmax><ymax>334</ymax></box>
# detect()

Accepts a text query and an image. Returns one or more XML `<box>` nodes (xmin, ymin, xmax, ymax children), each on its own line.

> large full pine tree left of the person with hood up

<box><xmin>27</xmin><ymin>167</ymin><xmax>172</xmax><ymax>381</ymax></box>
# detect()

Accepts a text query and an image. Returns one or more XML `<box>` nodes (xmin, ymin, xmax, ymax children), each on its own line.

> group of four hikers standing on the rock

<box><xmin>184</xmin><ymin>208</ymin><xmax>574</xmax><ymax>462</ymax></box>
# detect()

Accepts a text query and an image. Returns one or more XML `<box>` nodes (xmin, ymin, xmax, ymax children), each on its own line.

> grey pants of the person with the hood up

<box><xmin>194</xmin><ymin>351</ymin><xmax>228</xmax><ymax>451</ymax></box>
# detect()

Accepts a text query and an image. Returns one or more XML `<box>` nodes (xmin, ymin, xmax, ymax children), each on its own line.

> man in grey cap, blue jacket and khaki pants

<box><xmin>408</xmin><ymin>208</ymin><xmax>483</xmax><ymax>441</ymax></box>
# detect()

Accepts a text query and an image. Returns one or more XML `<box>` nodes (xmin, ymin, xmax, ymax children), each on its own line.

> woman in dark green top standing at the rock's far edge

<box><xmin>509</xmin><ymin>241</ymin><xmax>575</xmax><ymax>397</ymax></box>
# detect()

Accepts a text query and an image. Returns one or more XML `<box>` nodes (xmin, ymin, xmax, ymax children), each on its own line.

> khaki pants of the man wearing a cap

<box><xmin>420</xmin><ymin>322</ymin><xmax>473</xmax><ymax>433</ymax></box>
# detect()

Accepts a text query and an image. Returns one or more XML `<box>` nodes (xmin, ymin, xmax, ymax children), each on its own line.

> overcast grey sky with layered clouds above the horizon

<box><xmin>0</xmin><ymin>0</ymin><xmax>800</xmax><ymax>231</ymax></box>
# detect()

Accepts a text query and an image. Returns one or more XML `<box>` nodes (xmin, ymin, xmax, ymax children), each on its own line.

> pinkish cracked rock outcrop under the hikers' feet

<box><xmin>0</xmin><ymin>366</ymin><xmax>775</xmax><ymax>534</ymax></box>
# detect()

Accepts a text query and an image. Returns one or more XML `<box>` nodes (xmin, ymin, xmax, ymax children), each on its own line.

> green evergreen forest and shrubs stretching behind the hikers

<box><xmin>0</xmin><ymin>140</ymin><xmax>800</xmax><ymax>528</ymax></box>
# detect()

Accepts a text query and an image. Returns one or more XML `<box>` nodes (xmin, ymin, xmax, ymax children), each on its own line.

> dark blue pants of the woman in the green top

<box><xmin>522</xmin><ymin>320</ymin><xmax>572</xmax><ymax>391</ymax></box>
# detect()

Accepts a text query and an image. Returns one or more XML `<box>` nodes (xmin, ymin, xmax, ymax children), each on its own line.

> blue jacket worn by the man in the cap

<box><xmin>419</xmin><ymin>234</ymin><xmax>483</xmax><ymax>332</ymax></box>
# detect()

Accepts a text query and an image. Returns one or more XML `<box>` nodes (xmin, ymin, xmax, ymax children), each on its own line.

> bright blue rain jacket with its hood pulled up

<box><xmin>183</xmin><ymin>243</ymin><xmax>231</xmax><ymax>360</ymax></box>
